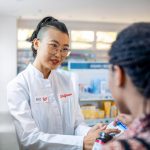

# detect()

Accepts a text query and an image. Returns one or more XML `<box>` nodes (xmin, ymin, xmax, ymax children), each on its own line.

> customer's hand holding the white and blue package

<box><xmin>114</xmin><ymin>114</ymin><xmax>133</xmax><ymax>126</ymax></box>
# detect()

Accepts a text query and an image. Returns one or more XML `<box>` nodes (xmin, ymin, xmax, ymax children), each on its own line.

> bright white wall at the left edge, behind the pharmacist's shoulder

<box><xmin>0</xmin><ymin>16</ymin><xmax>17</xmax><ymax>111</ymax></box>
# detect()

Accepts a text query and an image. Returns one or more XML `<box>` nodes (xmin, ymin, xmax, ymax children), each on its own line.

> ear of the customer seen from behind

<box><xmin>114</xmin><ymin>65</ymin><xmax>125</xmax><ymax>87</ymax></box>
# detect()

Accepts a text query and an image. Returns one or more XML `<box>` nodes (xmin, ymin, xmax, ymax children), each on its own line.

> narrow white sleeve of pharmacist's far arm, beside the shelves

<box><xmin>71</xmin><ymin>73</ymin><xmax>91</xmax><ymax>136</ymax></box>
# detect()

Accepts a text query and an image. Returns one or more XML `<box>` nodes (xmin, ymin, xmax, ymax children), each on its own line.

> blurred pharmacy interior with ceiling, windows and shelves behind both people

<box><xmin>0</xmin><ymin>0</ymin><xmax>150</xmax><ymax>150</ymax></box>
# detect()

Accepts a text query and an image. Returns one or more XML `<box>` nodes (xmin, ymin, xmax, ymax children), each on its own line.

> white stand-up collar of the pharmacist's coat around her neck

<box><xmin>28</xmin><ymin>63</ymin><xmax>53</xmax><ymax>80</ymax></box>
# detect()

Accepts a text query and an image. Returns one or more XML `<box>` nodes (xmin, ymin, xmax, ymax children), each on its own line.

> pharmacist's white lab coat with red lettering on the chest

<box><xmin>7</xmin><ymin>64</ymin><xmax>90</xmax><ymax>150</ymax></box>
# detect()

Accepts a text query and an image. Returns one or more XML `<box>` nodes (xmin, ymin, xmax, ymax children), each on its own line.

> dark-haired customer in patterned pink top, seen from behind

<box><xmin>102</xmin><ymin>23</ymin><xmax>150</xmax><ymax>150</ymax></box>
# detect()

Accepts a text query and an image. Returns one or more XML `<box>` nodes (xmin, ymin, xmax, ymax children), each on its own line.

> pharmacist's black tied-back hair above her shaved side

<box><xmin>27</xmin><ymin>16</ymin><xmax>69</xmax><ymax>57</ymax></box>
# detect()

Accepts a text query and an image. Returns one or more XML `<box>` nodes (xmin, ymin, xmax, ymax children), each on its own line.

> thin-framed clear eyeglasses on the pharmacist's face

<box><xmin>48</xmin><ymin>43</ymin><xmax>71</xmax><ymax>57</ymax></box>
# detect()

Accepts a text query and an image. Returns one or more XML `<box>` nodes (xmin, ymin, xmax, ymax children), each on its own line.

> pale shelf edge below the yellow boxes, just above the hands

<box><xmin>85</xmin><ymin>118</ymin><xmax>114</xmax><ymax>126</ymax></box>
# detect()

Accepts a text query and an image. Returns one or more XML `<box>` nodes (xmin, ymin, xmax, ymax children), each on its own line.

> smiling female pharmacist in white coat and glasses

<box><xmin>7</xmin><ymin>17</ymin><xmax>118</xmax><ymax>150</ymax></box>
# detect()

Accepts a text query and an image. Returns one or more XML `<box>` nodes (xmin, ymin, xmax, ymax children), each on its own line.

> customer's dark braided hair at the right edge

<box><xmin>109</xmin><ymin>23</ymin><xmax>150</xmax><ymax>99</ymax></box>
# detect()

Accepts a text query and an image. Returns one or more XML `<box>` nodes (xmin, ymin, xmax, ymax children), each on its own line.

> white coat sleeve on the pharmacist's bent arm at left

<box><xmin>7</xmin><ymin>84</ymin><xmax>83</xmax><ymax>150</ymax></box>
